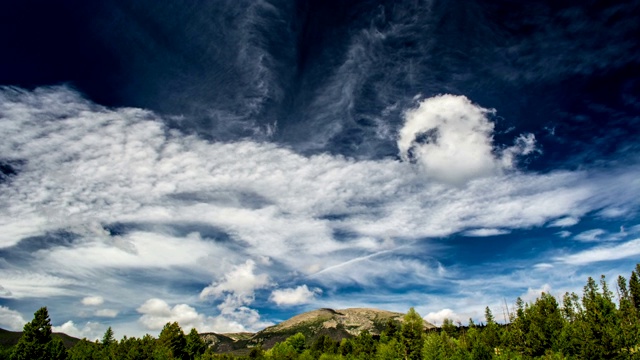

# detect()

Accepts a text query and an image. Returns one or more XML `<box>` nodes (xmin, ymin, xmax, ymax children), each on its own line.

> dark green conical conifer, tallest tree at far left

<box><xmin>11</xmin><ymin>307</ymin><xmax>66</xmax><ymax>360</ymax></box>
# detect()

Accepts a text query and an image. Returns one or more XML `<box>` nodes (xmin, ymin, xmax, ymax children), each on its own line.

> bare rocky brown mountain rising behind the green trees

<box><xmin>200</xmin><ymin>308</ymin><xmax>435</xmax><ymax>354</ymax></box>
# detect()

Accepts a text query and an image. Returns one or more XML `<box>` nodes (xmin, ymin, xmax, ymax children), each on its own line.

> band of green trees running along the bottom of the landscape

<box><xmin>9</xmin><ymin>264</ymin><xmax>640</xmax><ymax>360</ymax></box>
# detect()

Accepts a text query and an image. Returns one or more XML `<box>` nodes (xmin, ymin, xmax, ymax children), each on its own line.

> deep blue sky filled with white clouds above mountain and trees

<box><xmin>0</xmin><ymin>0</ymin><xmax>640</xmax><ymax>339</ymax></box>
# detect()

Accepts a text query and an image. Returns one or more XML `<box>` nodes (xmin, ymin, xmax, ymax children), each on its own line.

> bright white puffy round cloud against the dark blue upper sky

<box><xmin>398</xmin><ymin>94</ymin><xmax>535</xmax><ymax>185</ymax></box>
